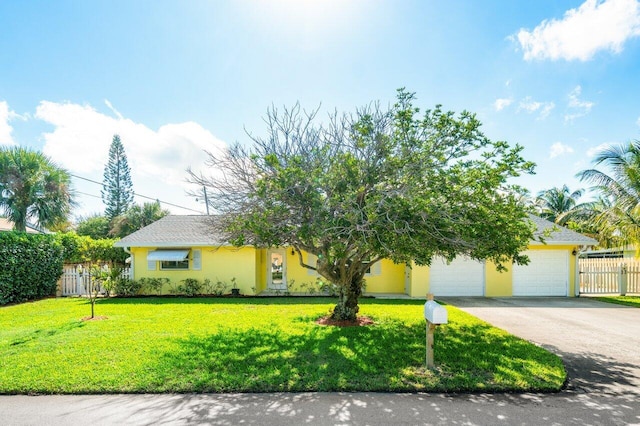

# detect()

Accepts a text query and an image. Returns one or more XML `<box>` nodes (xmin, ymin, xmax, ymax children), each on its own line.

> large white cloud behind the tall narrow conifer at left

<box><xmin>36</xmin><ymin>101</ymin><xmax>226</xmax><ymax>214</ymax></box>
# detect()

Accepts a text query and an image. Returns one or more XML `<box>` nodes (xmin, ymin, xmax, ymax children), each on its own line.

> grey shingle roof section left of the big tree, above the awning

<box><xmin>114</xmin><ymin>215</ymin><xmax>225</xmax><ymax>247</ymax></box>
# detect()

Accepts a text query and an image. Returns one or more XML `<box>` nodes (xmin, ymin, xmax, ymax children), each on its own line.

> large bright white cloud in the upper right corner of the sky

<box><xmin>515</xmin><ymin>0</ymin><xmax>640</xmax><ymax>61</ymax></box>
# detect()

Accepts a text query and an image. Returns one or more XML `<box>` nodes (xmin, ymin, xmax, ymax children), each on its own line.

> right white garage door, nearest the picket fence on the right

<box><xmin>513</xmin><ymin>250</ymin><xmax>569</xmax><ymax>296</ymax></box>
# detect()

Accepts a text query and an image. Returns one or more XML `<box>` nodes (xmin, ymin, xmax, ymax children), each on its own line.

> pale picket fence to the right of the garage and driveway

<box><xmin>578</xmin><ymin>258</ymin><xmax>640</xmax><ymax>295</ymax></box>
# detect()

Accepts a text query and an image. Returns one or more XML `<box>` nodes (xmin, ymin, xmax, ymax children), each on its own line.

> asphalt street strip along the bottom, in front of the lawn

<box><xmin>0</xmin><ymin>393</ymin><xmax>640</xmax><ymax>426</ymax></box>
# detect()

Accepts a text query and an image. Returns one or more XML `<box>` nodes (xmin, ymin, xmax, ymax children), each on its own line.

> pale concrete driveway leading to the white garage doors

<box><xmin>440</xmin><ymin>297</ymin><xmax>640</xmax><ymax>395</ymax></box>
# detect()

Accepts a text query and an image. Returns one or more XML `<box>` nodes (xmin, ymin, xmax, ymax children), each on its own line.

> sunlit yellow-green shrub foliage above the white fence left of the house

<box><xmin>55</xmin><ymin>232</ymin><xmax>129</xmax><ymax>265</ymax></box>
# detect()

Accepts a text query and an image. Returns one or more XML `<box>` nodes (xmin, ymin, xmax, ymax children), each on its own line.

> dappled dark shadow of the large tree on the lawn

<box><xmin>146</xmin><ymin>318</ymin><xmax>564</xmax><ymax>392</ymax></box>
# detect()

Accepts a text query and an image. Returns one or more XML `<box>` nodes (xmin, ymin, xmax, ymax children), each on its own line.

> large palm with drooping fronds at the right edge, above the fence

<box><xmin>577</xmin><ymin>141</ymin><xmax>640</xmax><ymax>243</ymax></box>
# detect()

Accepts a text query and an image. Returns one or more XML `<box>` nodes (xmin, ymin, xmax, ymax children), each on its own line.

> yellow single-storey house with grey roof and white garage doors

<box><xmin>115</xmin><ymin>216</ymin><xmax>596</xmax><ymax>298</ymax></box>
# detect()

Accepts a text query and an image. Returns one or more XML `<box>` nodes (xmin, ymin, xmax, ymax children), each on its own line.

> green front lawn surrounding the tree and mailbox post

<box><xmin>0</xmin><ymin>298</ymin><xmax>566</xmax><ymax>393</ymax></box>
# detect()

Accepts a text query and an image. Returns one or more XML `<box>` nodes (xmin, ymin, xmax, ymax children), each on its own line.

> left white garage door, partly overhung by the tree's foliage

<box><xmin>429</xmin><ymin>257</ymin><xmax>484</xmax><ymax>297</ymax></box>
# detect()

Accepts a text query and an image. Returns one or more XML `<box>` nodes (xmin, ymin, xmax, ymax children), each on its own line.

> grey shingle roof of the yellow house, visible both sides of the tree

<box><xmin>114</xmin><ymin>215</ymin><xmax>597</xmax><ymax>247</ymax></box>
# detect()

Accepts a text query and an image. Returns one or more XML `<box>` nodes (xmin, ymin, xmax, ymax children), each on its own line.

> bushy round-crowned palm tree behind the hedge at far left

<box><xmin>0</xmin><ymin>147</ymin><xmax>74</xmax><ymax>231</ymax></box>
